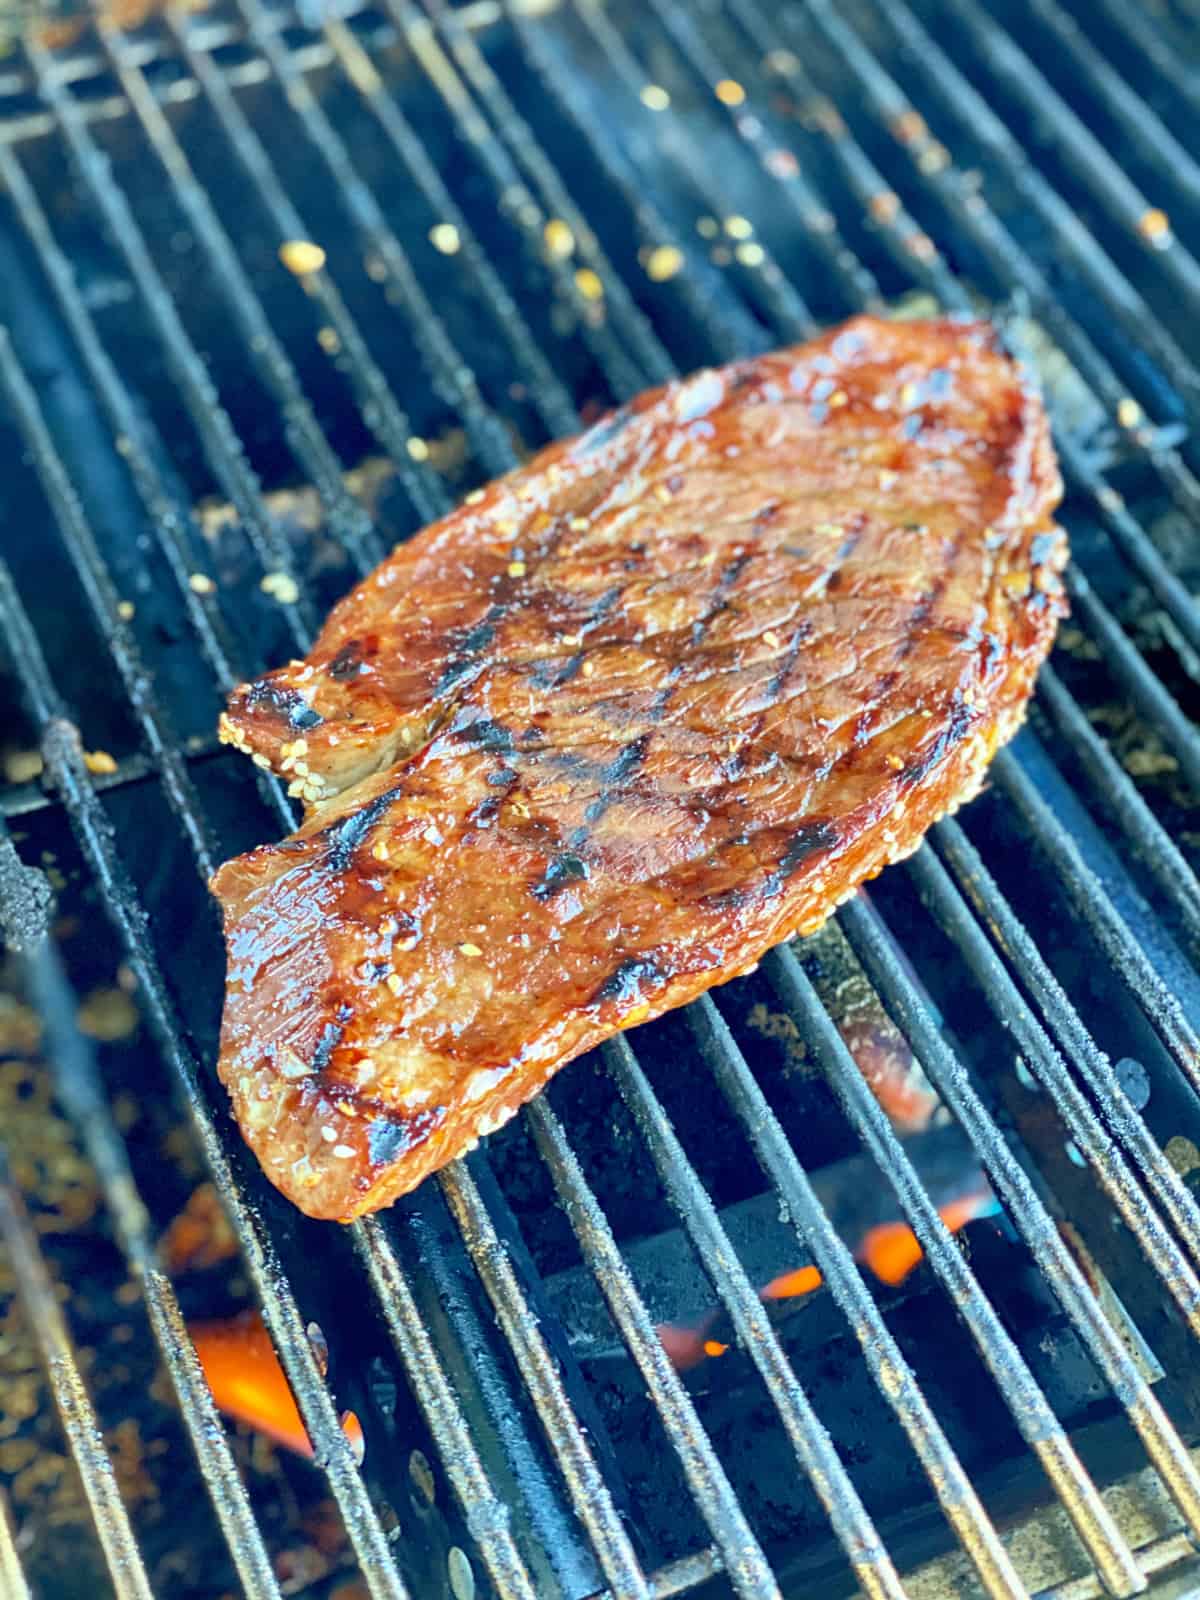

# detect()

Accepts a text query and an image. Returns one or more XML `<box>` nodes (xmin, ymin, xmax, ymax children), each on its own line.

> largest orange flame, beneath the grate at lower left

<box><xmin>187</xmin><ymin>1312</ymin><xmax>365</xmax><ymax>1461</ymax></box>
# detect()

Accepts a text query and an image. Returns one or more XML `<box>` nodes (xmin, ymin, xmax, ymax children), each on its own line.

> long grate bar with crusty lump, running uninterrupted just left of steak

<box><xmin>0</xmin><ymin>566</ymin><xmax>406</xmax><ymax>1600</ymax></box>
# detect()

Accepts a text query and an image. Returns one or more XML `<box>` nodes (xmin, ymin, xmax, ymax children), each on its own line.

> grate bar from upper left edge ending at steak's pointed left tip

<box><xmin>0</xmin><ymin>139</ymin><xmax>249</xmax><ymax>690</ymax></box>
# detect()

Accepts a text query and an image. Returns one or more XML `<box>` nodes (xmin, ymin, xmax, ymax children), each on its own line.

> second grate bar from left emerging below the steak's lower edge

<box><xmin>438</xmin><ymin>1160</ymin><xmax>650</xmax><ymax>1600</ymax></box>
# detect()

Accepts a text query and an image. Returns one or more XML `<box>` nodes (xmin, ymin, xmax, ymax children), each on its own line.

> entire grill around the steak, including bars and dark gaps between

<box><xmin>0</xmin><ymin>0</ymin><xmax>1200</xmax><ymax>1600</ymax></box>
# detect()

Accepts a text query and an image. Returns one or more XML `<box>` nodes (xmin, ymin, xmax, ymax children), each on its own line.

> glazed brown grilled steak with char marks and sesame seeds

<box><xmin>213</xmin><ymin>318</ymin><xmax>1066</xmax><ymax>1221</ymax></box>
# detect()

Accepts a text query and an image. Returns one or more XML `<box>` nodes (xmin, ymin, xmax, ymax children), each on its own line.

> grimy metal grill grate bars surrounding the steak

<box><xmin>0</xmin><ymin>0</ymin><xmax>1200</xmax><ymax>1600</ymax></box>
